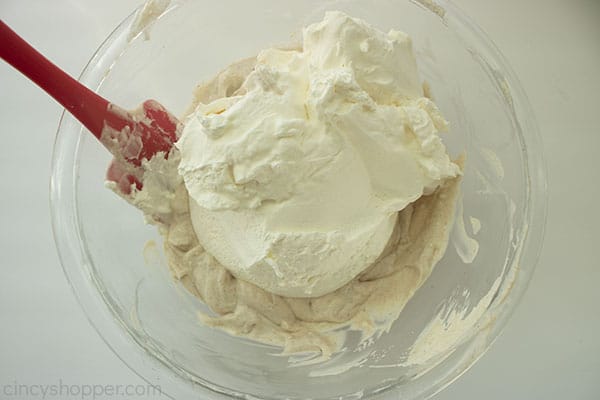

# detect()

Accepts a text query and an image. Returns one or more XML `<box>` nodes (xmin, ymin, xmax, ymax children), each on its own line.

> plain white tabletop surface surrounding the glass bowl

<box><xmin>0</xmin><ymin>0</ymin><xmax>600</xmax><ymax>400</ymax></box>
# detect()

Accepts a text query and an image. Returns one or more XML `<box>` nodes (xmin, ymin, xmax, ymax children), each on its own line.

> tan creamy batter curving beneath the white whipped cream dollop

<box><xmin>159</xmin><ymin>158</ymin><xmax>460</xmax><ymax>359</ymax></box>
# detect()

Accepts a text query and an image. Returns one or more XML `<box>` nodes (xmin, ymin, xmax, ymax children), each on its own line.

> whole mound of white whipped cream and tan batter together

<box><xmin>111</xmin><ymin>12</ymin><xmax>462</xmax><ymax>358</ymax></box>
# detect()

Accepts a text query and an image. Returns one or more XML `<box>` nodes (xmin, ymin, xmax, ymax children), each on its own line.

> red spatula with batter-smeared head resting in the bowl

<box><xmin>0</xmin><ymin>20</ymin><xmax>181</xmax><ymax>194</ymax></box>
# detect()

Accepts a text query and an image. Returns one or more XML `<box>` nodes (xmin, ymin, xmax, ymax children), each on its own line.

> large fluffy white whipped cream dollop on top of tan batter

<box><xmin>176</xmin><ymin>12</ymin><xmax>460</xmax><ymax>297</ymax></box>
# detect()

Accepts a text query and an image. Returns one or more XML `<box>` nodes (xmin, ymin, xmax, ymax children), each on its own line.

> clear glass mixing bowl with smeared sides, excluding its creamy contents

<box><xmin>51</xmin><ymin>0</ymin><xmax>546</xmax><ymax>399</ymax></box>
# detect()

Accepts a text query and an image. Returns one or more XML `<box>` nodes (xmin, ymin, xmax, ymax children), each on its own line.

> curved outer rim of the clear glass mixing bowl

<box><xmin>50</xmin><ymin>0</ymin><xmax>547</xmax><ymax>399</ymax></box>
